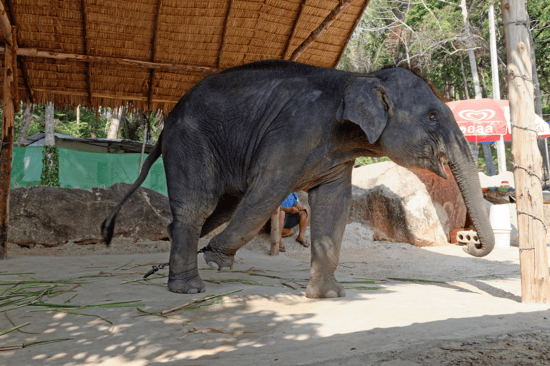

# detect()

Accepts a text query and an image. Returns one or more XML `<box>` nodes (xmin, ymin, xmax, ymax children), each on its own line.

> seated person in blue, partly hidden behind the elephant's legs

<box><xmin>266</xmin><ymin>193</ymin><xmax>309</xmax><ymax>252</ymax></box>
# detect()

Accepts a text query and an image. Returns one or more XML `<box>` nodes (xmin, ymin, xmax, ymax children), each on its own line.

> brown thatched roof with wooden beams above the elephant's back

<box><xmin>0</xmin><ymin>0</ymin><xmax>369</xmax><ymax>112</ymax></box>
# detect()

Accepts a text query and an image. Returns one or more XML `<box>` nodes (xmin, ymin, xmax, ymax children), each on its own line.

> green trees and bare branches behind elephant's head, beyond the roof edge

<box><xmin>338</xmin><ymin>0</ymin><xmax>550</xmax><ymax>120</ymax></box>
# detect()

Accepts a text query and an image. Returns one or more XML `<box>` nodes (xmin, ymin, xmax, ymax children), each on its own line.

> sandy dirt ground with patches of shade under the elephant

<box><xmin>0</xmin><ymin>223</ymin><xmax>550</xmax><ymax>366</ymax></box>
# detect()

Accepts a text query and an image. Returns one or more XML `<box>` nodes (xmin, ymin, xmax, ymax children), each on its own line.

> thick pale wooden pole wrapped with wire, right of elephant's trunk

<box><xmin>502</xmin><ymin>0</ymin><xmax>550</xmax><ymax>304</ymax></box>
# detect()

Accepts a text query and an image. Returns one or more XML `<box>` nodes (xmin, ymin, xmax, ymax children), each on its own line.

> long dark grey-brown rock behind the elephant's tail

<box><xmin>8</xmin><ymin>183</ymin><xmax>172</xmax><ymax>246</ymax></box>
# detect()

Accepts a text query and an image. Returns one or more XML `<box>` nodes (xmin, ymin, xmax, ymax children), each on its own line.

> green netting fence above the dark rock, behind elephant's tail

<box><xmin>11</xmin><ymin>146</ymin><xmax>167</xmax><ymax>195</ymax></box>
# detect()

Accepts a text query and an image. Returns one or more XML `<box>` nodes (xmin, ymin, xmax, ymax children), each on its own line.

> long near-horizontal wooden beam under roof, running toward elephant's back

<box><xmin>0</xmin><ymin>46</ymin><xmax>221</xmax><ymax>74</ymax></box>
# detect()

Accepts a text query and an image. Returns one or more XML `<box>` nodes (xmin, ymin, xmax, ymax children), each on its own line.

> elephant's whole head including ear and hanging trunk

<box><xmin>339</xmin><ymin>68</ymin><xmax>494</xmax><ymax>257</ymax></box>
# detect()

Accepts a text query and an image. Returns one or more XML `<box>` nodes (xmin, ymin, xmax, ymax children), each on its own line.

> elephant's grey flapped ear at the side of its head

<box><xmin>341</xmin><ymin>77</ymin><xmax>390</xmax><ymax>144</ymax></box>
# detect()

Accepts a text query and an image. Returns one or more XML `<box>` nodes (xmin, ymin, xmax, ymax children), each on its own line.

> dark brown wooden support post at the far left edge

<box><xmin>0</xmin><ymin>25</ymin><xmax>17</xmax><ymax>259</ymax></box>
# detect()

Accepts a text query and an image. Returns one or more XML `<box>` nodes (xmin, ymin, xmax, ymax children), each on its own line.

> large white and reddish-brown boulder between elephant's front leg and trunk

<box><xmin>350</xmin><ymin>162</ymin><xmax>467</xmax><ymax>246</ymax></box>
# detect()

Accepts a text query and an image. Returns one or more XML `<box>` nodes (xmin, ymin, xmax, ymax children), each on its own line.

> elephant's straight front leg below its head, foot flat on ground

<box><xmin>306</xmin><ymin>166</ymin><xmax>351</xmax><ymax>298</ymax></box>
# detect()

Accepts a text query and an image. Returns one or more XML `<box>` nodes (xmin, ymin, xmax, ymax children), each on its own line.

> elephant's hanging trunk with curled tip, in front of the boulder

<box><xmin>445</xmin><ymin>130</ymin><xmax>495</xmax><ymax>257</ymax></box>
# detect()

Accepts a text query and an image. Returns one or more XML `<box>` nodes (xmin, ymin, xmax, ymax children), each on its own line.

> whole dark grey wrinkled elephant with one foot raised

<box><xmin>102</xmin><ymin>61</ymin><xmax>494</xmax><ymax>298</ymax></box>
